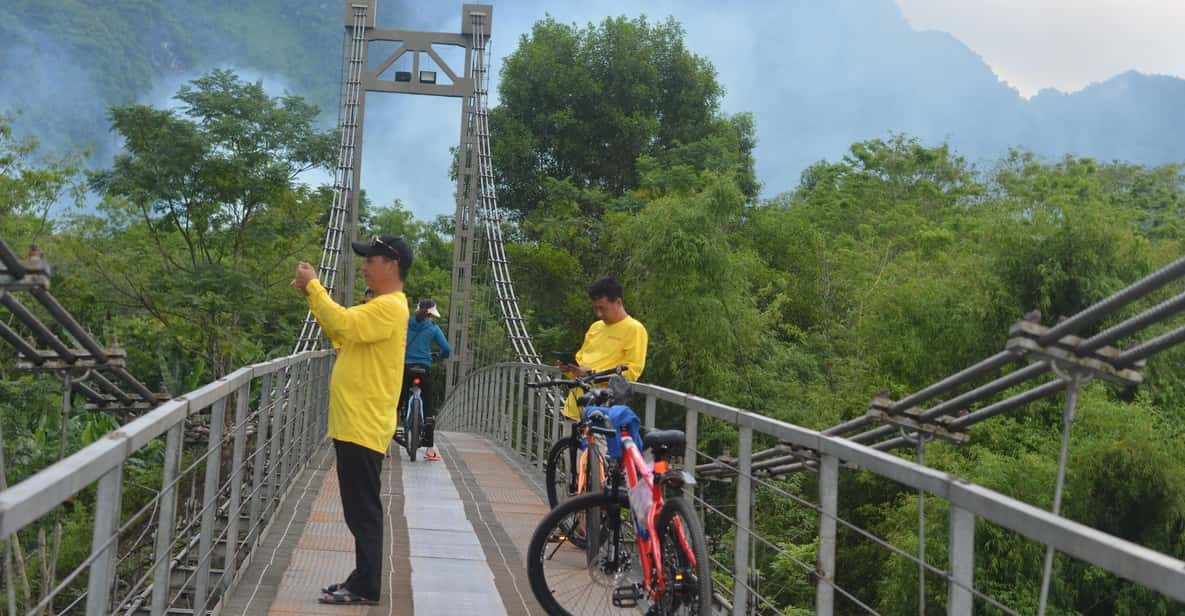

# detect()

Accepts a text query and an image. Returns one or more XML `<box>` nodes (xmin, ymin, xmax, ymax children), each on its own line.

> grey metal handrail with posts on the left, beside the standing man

<box><xmin>0</xmin><ymin>351</ymin><xmax>333</xmax><ymax>614</ymax></box>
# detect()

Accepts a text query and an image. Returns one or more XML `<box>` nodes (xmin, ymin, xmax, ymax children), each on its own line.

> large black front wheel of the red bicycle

<box><xmin>526</xmin><ymin>490</ymin><xmax>645</xmax><ymax>616</ymax></box>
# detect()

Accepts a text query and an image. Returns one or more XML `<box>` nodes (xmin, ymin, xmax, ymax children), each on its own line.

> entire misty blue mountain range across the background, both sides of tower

<box><xmin>0</xmin><ymin>0</ymin><xmax>1185</xmax><ymax>211</ymax></box>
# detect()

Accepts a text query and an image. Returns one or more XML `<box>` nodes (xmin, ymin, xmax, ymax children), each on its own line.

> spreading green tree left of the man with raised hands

<box><xmin>84</xmin><ymin>70</ymin><xmax>335</xmax><ymax>378</ymax></box>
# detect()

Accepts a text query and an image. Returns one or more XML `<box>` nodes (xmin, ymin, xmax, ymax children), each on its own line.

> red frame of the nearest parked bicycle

<box><xmin>611</xmin><ymin>430</ymin><xmax>696</xmax><ymax>602</ymax></box>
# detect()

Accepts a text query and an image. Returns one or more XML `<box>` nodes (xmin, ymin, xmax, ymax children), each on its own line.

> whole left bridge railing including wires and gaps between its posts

<box><xmin>0</xmin><ymin>351</ymin><xmax>333</xmax><ymax>615</ymax></box>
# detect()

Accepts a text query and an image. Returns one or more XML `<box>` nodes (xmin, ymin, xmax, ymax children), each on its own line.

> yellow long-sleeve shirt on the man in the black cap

<box><xmin>307</xmin><ymin>280</ymin><xmax>409</xmax><ymax>453</ymax></box>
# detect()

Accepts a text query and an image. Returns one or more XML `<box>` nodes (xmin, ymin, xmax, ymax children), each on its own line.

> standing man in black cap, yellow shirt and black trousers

<box><xmin>293</xmin><ymin>236</ymin><xmax>412</xmax><ymax>605</ymax></box>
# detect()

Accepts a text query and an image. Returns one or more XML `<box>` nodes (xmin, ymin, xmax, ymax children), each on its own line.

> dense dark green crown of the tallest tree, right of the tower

<box><xmin>491</xmin><ymin>18</ymin><xmax>723</xmax><ymax>212</ymax></box>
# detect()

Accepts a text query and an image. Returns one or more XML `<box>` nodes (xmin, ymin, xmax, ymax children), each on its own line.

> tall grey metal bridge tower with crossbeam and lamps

<box><xmin>296</xmin><ymin>0</ymin><xmax>539</xmax><ymax>387</ymax></box>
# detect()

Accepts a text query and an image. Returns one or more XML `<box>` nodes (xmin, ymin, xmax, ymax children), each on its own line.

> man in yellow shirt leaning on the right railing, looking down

<box><xmin>559</xmin><ymin>277</ymin><xmax>649</xmax><ymax>421</ymax></box>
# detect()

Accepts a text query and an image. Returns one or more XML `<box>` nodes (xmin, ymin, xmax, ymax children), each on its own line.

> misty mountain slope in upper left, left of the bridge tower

<box><xmin>0</xmin><ymin>0</ymin><xmax>342</xmax><ymax>163</ymax></box>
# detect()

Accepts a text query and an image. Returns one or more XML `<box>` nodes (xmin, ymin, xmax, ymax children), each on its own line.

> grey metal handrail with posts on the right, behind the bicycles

<box><xmin>437</xmin><ymin>362</ymin><xmax>1185</xmax><ymax>614</ymax></box>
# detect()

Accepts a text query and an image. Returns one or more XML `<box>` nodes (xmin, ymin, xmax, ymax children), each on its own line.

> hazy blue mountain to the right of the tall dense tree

<box><xmin>730</xmin><ymin>0</ymin><xmax>1185</xmax><ymax>193</ymax></box>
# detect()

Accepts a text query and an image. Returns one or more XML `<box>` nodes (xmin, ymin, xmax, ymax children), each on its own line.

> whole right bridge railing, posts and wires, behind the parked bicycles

<box><xmin>440</xmin><ymin>362</ymin><xmax>1185</xmax><ymax>615</ymax></box>
